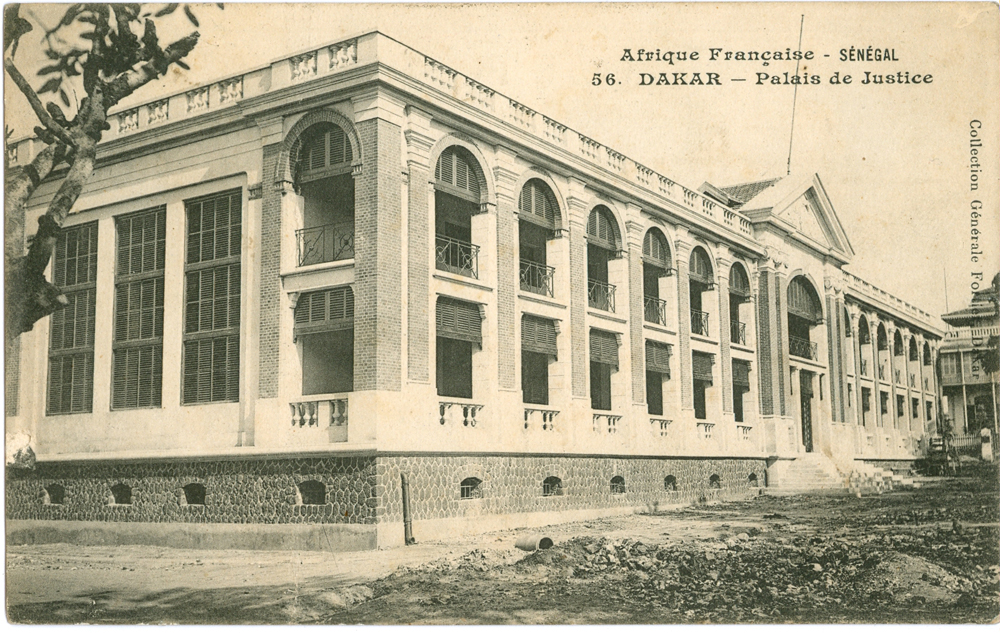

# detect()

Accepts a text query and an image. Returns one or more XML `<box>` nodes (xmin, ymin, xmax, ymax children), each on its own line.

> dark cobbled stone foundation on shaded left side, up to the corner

<box><xmin>6</xmin><ymin>457</ymin><xmax>376</xmax><ymax>523</ymax></box>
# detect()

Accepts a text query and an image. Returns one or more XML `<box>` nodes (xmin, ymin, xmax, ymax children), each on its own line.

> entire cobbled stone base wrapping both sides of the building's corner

<box><xmin>6</xmin><ymin>453</ymin><xmax>766</xmax><ymax>551</ymax></box>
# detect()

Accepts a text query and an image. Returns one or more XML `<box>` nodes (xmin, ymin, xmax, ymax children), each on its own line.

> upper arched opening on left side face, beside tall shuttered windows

<box><xmin>292</xmin><ymin>122</ymin><xmax>354</xmax><ymax>266</ymax></box>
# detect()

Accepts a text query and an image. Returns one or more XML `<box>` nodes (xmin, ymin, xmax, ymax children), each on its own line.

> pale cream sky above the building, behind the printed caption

<box><xmin>5</xmin><ymin>3</ymin><xmax>1000</xmax><ymax>314</ymax></box>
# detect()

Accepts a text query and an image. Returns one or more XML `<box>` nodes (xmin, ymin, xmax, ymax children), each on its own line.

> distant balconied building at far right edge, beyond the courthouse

<box><xmin>940</xmin><ymin>287</ymin><xmax>1000</xmax><ymax>441</ymax></box>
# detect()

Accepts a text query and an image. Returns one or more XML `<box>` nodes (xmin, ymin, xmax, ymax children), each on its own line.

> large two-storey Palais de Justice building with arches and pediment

<box><xmin>7</xmin><ymin>32</ymin><xmax>941</xmax><ymax>546</ymax></box>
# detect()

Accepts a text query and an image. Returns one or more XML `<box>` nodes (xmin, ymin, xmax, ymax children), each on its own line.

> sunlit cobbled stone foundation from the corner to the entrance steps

<box><xmin>377</xmin><ymin>455</ymin><xmax>766</xmax><ymax>523</ymax></box>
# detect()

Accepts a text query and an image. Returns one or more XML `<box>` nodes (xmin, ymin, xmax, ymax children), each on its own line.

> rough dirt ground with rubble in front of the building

<box><xmin>7</xmin><ymin>479</ymin><xmax>1000</xmax><ymax>624</ymax></box>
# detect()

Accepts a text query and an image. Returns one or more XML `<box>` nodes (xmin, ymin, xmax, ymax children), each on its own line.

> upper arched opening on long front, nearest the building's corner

<box><xmin>434</xmin><ymin>145</ymin><xmax>482</xmax><ymax>279</ymax></box>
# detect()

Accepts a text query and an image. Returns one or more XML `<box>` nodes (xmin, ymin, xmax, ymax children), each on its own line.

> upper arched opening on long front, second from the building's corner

<box><xmin>517</xmin><ymin>178</ymin><xmax>561</xmax><ymax>297</ymax></box>
